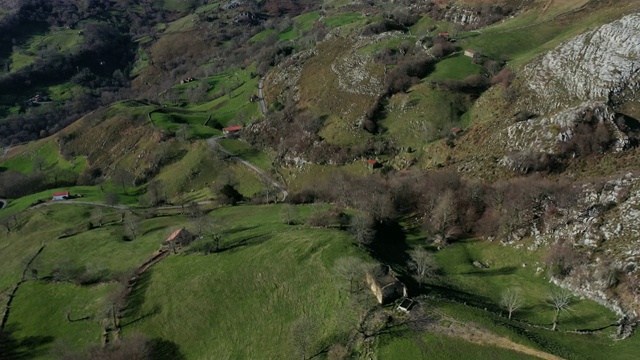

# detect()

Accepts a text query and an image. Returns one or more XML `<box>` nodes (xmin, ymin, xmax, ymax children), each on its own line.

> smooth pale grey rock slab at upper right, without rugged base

<box><xmin>520</xmin><ymin>13</ymin><xmax>640</xmax><ymax>114</ymax></box>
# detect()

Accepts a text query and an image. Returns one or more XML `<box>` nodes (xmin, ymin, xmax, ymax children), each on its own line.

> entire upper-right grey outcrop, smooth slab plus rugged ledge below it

<box><xmin>492</xmin><ymin>14</ymin><xmax>640</xmax><ymax>163</ymax></box>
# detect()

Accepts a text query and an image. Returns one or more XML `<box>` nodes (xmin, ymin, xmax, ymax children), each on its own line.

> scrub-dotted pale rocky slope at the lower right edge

<box><xmin>503</xmin><ymin>173</ymin><xmax>640</xmax><ymax>319</ymax></box>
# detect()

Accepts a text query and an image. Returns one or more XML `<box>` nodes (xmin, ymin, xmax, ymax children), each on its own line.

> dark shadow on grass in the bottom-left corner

<box><xmin>0</xmin><ymin>324</ymin><xmax>54</xmax><ymax>360</ymax></box>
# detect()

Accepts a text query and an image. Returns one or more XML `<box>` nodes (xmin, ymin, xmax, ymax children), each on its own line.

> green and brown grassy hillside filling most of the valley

<box><xmin>0</xmin><ymin>0</ymin><xmax>640</xmax><ymax>360</ymax></box>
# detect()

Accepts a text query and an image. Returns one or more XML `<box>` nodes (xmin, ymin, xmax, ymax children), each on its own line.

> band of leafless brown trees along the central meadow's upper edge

<box><xmin>290</xmin><ymin>171</ymin><xmax>575</xmax><ymax>244</ymax></box>
